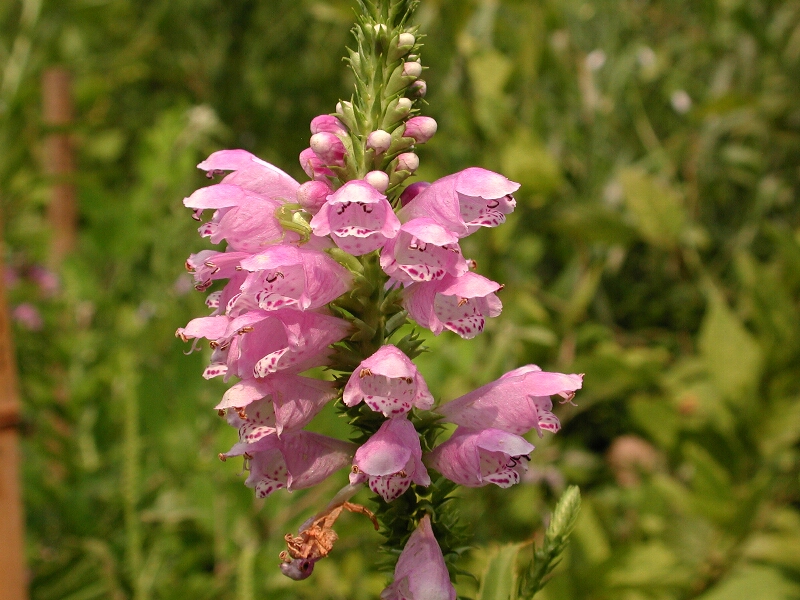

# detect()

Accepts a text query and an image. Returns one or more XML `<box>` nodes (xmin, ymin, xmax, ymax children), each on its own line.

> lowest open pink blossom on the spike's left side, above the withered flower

<box><xmin>220</xmin><ymin>431</ymin><xmax>355</xmax><ymax>498</ymax></box>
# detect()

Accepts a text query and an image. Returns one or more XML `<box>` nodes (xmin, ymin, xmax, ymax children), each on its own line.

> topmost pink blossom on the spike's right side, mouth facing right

<box><xmin>400</xmin><ymin>167</ymin><xmax>519</xmax><ymax>237</ymax></box>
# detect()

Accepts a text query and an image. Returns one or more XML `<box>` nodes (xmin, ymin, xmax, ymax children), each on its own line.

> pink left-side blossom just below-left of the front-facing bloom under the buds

<box><xmin>234</xmin><ymin>245</ymin><xmax>352</xmax><ymax>310</ymax></box>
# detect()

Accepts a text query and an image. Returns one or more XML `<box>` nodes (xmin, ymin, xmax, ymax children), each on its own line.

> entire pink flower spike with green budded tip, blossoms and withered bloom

<box><xmin>176</xmin><ymin>0</ymin><xmax>582</xmax><ymax>599</ymax></box>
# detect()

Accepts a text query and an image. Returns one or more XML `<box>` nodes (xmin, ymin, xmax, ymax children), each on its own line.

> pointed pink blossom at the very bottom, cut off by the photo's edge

<box><xmin>381</xmin><ymin>515</ymin><xmax>456</xmax><ymax>600</ymax></box>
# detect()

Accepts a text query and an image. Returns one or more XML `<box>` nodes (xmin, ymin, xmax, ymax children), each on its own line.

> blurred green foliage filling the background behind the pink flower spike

<box><xmin>0</xmin><ymin>0</ymin><xmax>800</xmax><ymax>600</ymax></box>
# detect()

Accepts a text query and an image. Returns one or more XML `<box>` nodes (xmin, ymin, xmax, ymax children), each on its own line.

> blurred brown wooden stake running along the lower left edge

<box><xmin>0</xmin><ymin>221</ymin><xmax>28</xmax><ymax>600</ymax></box>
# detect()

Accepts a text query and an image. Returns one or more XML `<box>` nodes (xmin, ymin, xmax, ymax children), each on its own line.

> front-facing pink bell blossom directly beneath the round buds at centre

<box><xmin>311</xmin><ymin>180</ymin><xmax>400</xmax><ymax>256</ymax></box>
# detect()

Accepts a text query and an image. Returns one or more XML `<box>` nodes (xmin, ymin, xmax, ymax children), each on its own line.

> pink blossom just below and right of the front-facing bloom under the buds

<box><xmin>381</xmin><ymin>218</ymin><xmax>468</xmax><ymax>283</ymax></box>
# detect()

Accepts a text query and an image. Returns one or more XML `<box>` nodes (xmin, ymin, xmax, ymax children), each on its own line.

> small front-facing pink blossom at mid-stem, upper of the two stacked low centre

<box><xmin>342</xmin><ymin>345</ymin><xmax>433</xmax><ymax>417</ymax></box>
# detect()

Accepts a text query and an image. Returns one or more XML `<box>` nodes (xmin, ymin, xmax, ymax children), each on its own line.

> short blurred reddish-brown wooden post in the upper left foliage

<box><xmin>42</xmin><ymin>67</ymin><xmax>77</xmax><ymax>269</ymax></box>
